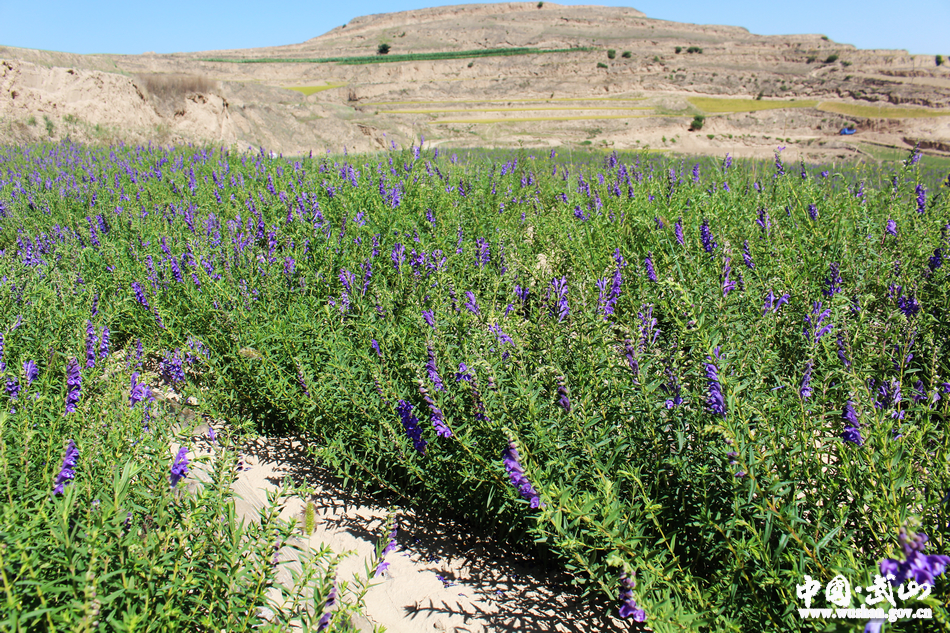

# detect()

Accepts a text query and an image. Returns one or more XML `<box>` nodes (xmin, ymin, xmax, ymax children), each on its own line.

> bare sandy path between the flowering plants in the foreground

<box><xmin>173</xmin><ymin>409</ymin><xmax>628</xmax><ymax>633</ymax></box>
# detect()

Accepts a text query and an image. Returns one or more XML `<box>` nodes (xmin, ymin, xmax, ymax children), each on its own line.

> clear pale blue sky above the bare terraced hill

<box><xmin>0</xmin><ymin>0</ymin><xmax>950</xmax><ymax>57</ymax></box>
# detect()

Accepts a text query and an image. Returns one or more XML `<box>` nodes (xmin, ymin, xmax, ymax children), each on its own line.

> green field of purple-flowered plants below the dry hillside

<box><xmin>0</xmin><ymin>143</ymin><xmax>950</xmax><ymax>631</ymax></box>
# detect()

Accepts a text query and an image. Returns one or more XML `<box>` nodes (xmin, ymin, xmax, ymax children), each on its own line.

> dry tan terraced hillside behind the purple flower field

<box><xmin>0</xmin><ymin>3</ymin><xmax>950</xmax><ymax>160</ymax></box>
